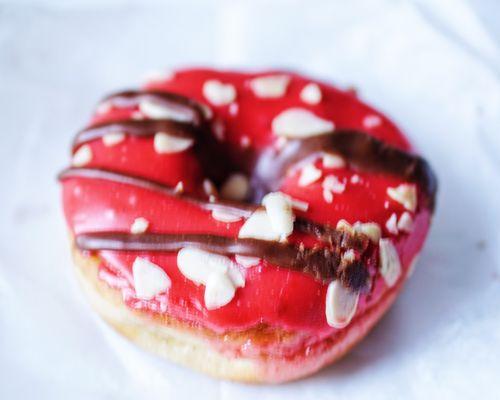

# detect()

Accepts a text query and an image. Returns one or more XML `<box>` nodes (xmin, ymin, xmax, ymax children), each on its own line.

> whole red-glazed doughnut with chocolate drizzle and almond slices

<box><xmin>58</xmin><ymin>69</ymin><xmax>437</xmax><ymax>383</ymax></box>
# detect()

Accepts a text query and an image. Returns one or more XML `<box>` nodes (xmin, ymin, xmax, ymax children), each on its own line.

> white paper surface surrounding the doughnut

<box><xmin>0</xmin><ymin>0</ymin><xmax>500</xmax><ymax>400</ymax></box>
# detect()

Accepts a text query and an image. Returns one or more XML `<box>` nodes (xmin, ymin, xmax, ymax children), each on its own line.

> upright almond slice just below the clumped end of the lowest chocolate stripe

<box><xmin>325</xmin><ymin>280</ymin><xmax>359</xmax><ymax>329</ymax></box>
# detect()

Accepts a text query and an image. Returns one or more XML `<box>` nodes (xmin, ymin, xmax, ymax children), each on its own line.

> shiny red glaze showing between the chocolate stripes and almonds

<box><xmin>63</xmin><ymin>70</ymin><xmax>430</xmax><ymax>353</ymax></box>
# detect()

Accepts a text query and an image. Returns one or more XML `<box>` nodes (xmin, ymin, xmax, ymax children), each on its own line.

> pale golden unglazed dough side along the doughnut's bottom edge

<box><xmin>72</xmin><ymin>245</ymin><xmax>418</xmax><ymax>383</ymax></box>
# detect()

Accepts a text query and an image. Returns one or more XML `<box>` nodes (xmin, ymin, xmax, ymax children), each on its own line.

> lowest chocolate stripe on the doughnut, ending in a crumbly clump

<box><xmin>76</xmin><ymin>232</ymin><xmax>369</xmax><ymax>290</ymax></box>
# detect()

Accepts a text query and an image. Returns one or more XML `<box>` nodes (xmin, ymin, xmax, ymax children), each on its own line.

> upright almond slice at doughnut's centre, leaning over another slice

<box><xmin>262</xmin><ymin>192</ymin><xmax>295</xmax><ymax>239</ymax></box>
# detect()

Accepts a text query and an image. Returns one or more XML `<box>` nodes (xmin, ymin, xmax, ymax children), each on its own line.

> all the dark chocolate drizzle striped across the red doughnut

<box><xmin>59</xmin><ymin>91</ymin><xmax>437</xmax><ymax>290</ymax></box>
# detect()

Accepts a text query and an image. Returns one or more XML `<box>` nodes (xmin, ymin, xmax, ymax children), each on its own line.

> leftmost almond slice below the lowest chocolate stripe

<box><xmin>132</xmin><ymin>257</ymin><xmax>172</xmax><ymax>300</ymax></box>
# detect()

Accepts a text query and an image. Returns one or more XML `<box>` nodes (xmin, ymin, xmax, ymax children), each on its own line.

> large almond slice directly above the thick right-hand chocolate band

<box><xmin>272</xmin><ymin>108</ymin><xmax>334</xmax><ymax>139</ymax></box>
